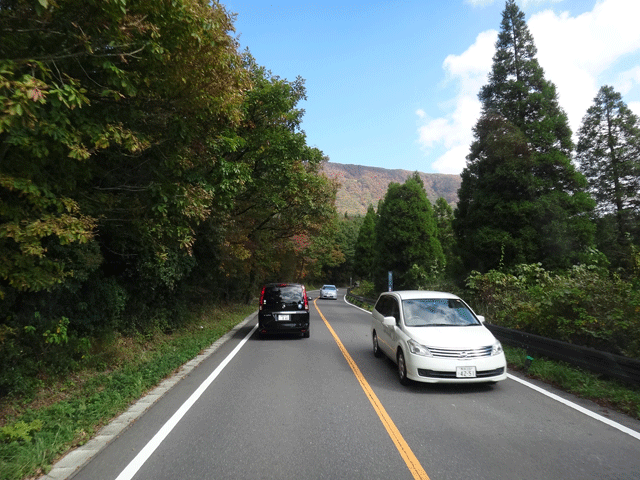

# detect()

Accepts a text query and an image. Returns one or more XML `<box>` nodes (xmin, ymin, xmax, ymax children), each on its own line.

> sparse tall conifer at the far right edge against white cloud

<box><xmin>576</xmin><ymin>86</ymin><xmax>640</xmax><ymax>264</ymax></box>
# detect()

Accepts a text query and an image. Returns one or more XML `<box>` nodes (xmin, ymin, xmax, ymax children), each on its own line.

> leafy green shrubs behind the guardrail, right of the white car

<box><xmin>467</xmin><ymin>264</ymin><xmax>640</xmax><ymax>358</ymax></box>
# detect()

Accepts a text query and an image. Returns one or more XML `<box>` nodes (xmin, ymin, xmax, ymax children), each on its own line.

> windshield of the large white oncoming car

<box><xmin>402</xmin><ymin>298</ymin><xmax>480</xmax><ymax>327</ymax></box>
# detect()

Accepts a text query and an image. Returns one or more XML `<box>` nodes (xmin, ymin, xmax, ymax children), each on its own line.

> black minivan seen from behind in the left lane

<box><xmin>258</xmin><ymin>283</ymin><xmax>309</xmax><ymax>338</ymax></box>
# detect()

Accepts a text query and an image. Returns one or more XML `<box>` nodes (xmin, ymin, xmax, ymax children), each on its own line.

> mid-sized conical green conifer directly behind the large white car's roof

<box><xmin>374</xmin><ymin>172</ymin><xmax>445</xmax><ymax>290</ymax></box>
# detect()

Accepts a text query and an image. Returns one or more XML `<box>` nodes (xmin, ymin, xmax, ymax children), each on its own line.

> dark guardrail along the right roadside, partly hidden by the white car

<box><xmin>347</xmin><ymin>293</ymin><xmax>640</xmax><ymax>385</ymax></box>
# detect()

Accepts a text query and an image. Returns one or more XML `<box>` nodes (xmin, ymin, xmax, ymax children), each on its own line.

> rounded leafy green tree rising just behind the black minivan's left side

<box><xmin>194</xmin><ymin>58</ymin><xmax>338</xmax><ymax>295</ymax></box>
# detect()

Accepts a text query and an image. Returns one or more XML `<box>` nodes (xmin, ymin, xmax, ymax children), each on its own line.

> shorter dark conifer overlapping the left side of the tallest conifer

<box><xmin>453</xmin><ymin>115</ymin><xmax>538</xmax><ymax>271</ymax></box>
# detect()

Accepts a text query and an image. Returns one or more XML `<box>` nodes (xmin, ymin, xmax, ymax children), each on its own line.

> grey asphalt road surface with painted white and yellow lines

<box><xmin>48</xmin><ymin>292</ymin><xmax>640</xmax><ymax>480</ymax></box>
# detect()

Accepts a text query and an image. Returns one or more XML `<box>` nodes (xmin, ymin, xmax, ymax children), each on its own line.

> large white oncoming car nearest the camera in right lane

<box><xmin>371</xmin><ymin>290</ymin><xmax>507</xmax><ymax>385</ymax></box>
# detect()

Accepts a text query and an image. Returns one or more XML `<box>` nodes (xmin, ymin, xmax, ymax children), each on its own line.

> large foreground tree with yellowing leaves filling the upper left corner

<box><xmin>0</xmin><ymin>0</ymin><xmax>244</xmax><ymax>326</ymax></box>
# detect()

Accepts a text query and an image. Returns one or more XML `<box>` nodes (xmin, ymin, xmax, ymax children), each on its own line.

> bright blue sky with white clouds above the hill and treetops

<box><xmin>221</xmin><ymin>0</ymin><xmax>640</xmax><ymax>173</ymax></box>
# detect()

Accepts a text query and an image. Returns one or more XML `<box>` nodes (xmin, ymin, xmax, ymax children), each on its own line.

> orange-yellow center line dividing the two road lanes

<box><xmin>313</xmin><ymin>299</ymin><xmax>429</xmax><ymax>480</ymax></box>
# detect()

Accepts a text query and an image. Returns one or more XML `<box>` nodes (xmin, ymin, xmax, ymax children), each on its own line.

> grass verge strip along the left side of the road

<box><xmin>0</xmin><ymin>305</ymin><xmax>255</xmax><ymax>480</ymax></box>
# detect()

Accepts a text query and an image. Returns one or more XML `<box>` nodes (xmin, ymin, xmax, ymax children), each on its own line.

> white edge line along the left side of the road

<box><xmin>116</xmin><ymin>324</ymin><xmax>258</xmax><ymax>480</ymax></box>
